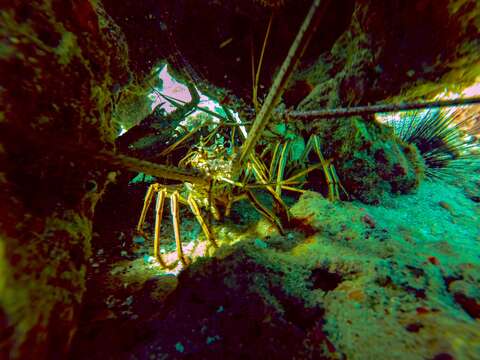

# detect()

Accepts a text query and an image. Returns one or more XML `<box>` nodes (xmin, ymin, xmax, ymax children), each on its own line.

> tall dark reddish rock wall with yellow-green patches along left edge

<box><xmin>0</xmin><ymin>0</ymin><xmax>129</xmax><ymax>359</ymax></box>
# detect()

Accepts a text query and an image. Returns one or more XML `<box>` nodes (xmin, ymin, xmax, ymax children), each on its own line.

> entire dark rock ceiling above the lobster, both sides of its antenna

<box><xmin>104</xmin><ymin>0</ymin><xmax>480</xmax><ymax>108</ymax></box>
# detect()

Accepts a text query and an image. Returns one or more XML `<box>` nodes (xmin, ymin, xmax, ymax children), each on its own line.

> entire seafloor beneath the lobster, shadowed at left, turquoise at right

<box><xmin>72</xmin><ymin>165</ymin><xmax>480</xmax><ymax>360</ymax></box>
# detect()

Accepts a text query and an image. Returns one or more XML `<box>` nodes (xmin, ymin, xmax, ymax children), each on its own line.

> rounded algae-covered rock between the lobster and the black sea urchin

<box><xmin>316</xmin><ymin>117</ymin><xmax>425</xmax><ymax>203</ymax></box>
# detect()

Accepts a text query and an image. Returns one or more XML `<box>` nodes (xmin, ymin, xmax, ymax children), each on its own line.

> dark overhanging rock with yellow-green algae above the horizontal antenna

<box><xmin>300</xmin><ymin>0</ymin><xmax>480</xmax><ymax>109</ymax></box>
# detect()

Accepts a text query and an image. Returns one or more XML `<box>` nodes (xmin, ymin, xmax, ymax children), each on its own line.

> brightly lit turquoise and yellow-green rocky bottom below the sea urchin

<box><xmin>292</xmin><ymin>191</ymin><xmax>480</xmax><ymax>360</ymax></box>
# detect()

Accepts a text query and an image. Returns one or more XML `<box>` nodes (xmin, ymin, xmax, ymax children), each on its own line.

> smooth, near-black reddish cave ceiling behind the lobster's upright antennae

<box><xmin>104</xmin><ymin>0</ymin><xmax>353</xmax><ymax>100</ymax></box>
